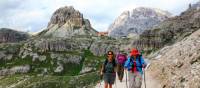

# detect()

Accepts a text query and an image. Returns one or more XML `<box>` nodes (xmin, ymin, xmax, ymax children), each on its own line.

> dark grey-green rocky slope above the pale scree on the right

<box><xmin>133</xmin><ymin>5</ymin><xmax>200</xmax><ymax>52</ymax></box>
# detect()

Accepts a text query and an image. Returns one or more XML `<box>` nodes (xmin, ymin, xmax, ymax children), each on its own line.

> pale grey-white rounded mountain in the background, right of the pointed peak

<box><xmin>108</xmin><ymin>7</ymin><xmax>170</xmax><ymax>37</ymax></box>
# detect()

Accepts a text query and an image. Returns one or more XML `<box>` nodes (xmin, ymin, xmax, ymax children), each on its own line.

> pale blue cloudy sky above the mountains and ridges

<box><xmin>0</xmin><ymin>0</ymin><xmax>199</xmax><ymax>32</ymax></box>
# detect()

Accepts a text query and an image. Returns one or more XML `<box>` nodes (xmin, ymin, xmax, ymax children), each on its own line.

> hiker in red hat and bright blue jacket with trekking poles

<box><xmin>124</xmin><ymin>48</ymin><xmax>146</xmax><ymax>88</ymax></box>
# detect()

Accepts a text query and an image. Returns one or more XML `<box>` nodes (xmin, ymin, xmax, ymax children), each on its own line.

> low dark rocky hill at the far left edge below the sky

<box><xmin>0</xmin><ymin>28</ymin><xmax>30</xmax><ymax>43</ymax></box>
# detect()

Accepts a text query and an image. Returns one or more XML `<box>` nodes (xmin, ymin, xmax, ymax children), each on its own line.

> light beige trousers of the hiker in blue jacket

<box><xmin>128</xmin><ymin>71</ymin><xmax>142</xmax><ymax>88</ymax></box>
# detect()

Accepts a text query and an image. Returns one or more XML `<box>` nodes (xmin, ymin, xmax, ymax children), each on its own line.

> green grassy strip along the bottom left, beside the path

<box><xmin>0</xmin><ymin>72</ymin><xmax>99</xmax><ymax>88</ymax></box>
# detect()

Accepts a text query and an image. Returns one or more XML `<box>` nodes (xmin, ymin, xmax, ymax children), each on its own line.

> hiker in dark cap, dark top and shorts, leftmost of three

<box><xmin>101</xmin><ymin>51</ymin><xmax>117</xmax><ymax>88</ymax></box>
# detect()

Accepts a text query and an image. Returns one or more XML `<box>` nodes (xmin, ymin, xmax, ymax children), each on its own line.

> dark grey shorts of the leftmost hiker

<box><xmin>103</xmin><ymin>73</ymin><xmax>116</xmax><ymax>84</ymax></box>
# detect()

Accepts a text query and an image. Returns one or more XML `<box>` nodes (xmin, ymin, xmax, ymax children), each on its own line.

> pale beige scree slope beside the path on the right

<box><xmin>150</xmin><ymin>30</ymin><xmax>200</xmax><ymax>88</ymax></box>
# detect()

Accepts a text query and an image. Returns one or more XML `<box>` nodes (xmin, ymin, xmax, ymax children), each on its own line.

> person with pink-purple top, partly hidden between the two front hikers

<box><xmin>116</xmin><ymin>51</ymin><xmax>127</xmax><ymax>82</ymax></box>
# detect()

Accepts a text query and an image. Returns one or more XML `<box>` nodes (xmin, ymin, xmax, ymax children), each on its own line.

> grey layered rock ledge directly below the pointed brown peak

<box><xmin>29</xmin><ymin>38</ymin><xmax>93</xmax><ymax>52</ymax></box>
